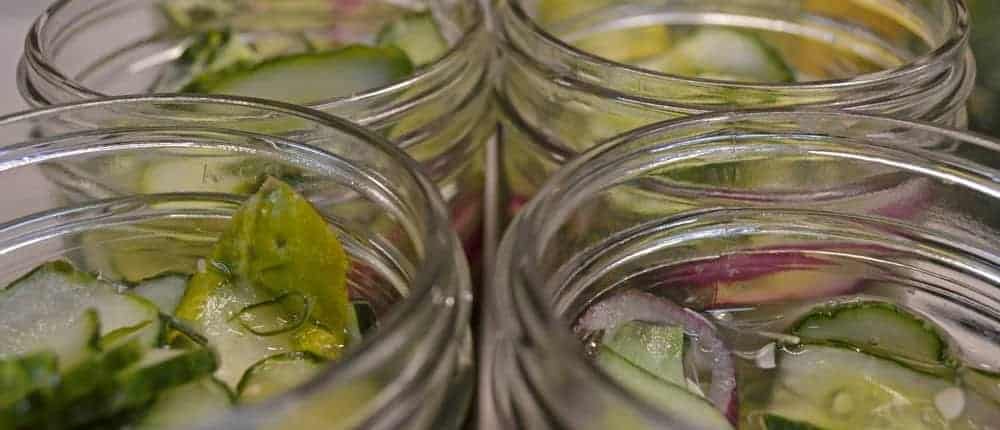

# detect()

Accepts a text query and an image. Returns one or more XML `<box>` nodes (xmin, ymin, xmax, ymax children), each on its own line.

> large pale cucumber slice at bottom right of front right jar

<box><xmin>764</xmin><ymin>345</ymin><xmax>1000</xmax><ymax>430</ymax></box>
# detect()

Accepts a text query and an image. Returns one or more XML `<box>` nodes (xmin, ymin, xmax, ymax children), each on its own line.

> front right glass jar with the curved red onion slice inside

<box><xmin>480</xmin><ymin>111</ymin><xmax>1000</xmax><ymax>429</ymax></box>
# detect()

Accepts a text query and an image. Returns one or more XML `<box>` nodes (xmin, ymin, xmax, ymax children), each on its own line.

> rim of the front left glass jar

<box><xmin>0</xmin><ymin>94</ymin><xmax>471</xmax><ymax>423</ymax></box>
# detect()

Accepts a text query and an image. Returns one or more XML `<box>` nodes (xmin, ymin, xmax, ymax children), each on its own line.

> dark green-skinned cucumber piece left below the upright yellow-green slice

<box><xmin>108</xmin><ymin>348</ymin><xmax>218</xmax><ymax>411</ymax></box>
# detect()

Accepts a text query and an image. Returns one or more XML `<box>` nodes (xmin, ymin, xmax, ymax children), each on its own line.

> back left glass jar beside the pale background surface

<box><xmin>18</xmin><ymin>0</ymin><xmax>495</xmax><ymax>268</ymax></box>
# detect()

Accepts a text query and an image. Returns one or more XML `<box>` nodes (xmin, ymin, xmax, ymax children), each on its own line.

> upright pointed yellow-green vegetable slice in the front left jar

<box><xmin>177</xmin><ymin>179</ymin><xmax>360</xmax><ymax>384</ymax></box>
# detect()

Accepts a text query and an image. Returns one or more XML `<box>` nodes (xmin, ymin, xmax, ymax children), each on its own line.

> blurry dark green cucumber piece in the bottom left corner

<box><xmin>0</xmin><ymin>352</ymin><xmax>60</xmax><ymax>429</ymax></box>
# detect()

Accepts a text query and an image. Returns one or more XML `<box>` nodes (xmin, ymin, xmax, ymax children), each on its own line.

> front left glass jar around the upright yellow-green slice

<box><xmin>0</xmin><ymin>95</ymin><xmax>474</xmax><ymax>429</ymax></box>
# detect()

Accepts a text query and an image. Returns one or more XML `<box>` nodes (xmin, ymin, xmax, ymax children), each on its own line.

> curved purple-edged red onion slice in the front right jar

<box><xmin>577</xmin><ymin>290</ymin><xmax>739</xmax><ymax>424</ymax></box>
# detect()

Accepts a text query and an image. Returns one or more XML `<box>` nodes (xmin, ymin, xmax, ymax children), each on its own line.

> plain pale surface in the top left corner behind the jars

<box><xmin>0</xmin><ymin>0</ymin><xmax>49</xmax><ymax>114</ymax></box>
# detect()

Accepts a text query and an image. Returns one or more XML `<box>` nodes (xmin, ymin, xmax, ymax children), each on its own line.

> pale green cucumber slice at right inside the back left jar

<box><xmin>377</xmin><ymin>12</ymin><xmax>448</xmax><ymax>66</ymax></box>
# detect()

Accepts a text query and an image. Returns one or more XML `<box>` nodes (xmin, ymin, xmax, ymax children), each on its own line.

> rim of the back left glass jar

<box><xmin>18</xmin><ymin>0</ymin><xmax>486</xmax><ymax>117</ymax></box>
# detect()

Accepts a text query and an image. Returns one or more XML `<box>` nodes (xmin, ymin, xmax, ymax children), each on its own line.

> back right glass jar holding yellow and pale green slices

<box><xmin>496</xmin><ymin>0</ymin><xmax>975</xmax><ymax>220</ymax></box>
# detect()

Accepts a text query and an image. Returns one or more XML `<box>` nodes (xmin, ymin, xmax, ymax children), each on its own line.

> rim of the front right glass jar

<box><xmin>491</xmin><ymin>109</ymin><xmax>1000</xmax><ymax>422</ymax></box>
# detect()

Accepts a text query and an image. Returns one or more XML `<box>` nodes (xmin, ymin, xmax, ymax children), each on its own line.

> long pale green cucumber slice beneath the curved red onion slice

<box><xmin>596</xmin><ymin>346</ymin><xmax>733</xmax><ymax>429</ymax></box>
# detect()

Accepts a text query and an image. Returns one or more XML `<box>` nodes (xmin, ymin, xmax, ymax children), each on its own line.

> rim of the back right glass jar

<box><xmin>501</xmin><ymin>0</ymin><xmax>970</xmax><ymax>91</ymax></box>
